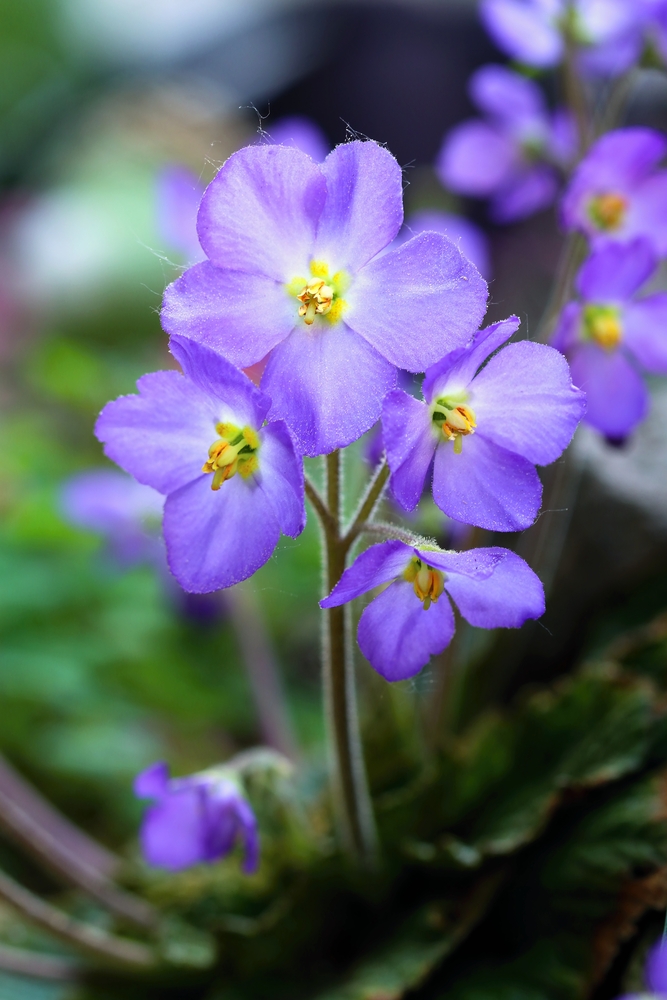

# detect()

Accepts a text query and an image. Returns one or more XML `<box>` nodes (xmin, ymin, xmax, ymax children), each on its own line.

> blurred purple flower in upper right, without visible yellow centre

<box><xmin>436</xmin><ymin>66</ymin><xmax>576</xmax><ymax>222</ymax></box>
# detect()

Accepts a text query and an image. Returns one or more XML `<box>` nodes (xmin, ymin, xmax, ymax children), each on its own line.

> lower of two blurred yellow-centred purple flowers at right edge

<box><xmin>552</xmin><ymin>239</ymin><xmax>667</xmax><ymax>439</ymax></box>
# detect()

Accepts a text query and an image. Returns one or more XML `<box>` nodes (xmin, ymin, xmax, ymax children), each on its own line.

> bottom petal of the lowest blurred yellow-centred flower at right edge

<box><xmin>570</xmin><ymin>344</ymin><xmax>649</xmax><ymax>438</ymax></box>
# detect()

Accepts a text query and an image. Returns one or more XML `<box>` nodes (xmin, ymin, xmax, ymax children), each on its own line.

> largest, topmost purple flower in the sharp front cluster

<box><xmin>162</xmin><ymin>142</ymin><xmax>487</xmax><ymax>455</ymax></box>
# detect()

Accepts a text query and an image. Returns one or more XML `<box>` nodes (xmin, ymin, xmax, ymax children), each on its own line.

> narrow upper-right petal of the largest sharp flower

<box><xmin>314</xmin><ymin>142</ymin><xmax>403</xmax><ymax>273</ymax></box>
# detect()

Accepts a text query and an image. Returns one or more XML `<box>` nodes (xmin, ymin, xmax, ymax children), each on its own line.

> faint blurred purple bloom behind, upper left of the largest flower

<box><xmin>156</xmin><ymin>164</ymin><xmax>205</xmax><ymax>264</ymax></box>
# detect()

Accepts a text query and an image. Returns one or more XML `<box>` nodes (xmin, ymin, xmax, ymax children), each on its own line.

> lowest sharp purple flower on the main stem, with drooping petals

<box><xmin>320</xmin><ymin>541</ymin><xmax>544</xmax><ymax>681</ymax></box>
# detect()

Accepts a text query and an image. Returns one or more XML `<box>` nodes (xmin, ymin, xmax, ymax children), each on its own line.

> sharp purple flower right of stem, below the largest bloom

<box><xmin>382</xmin><ymin>316</ymin><xmax>585</xmax><ymax>531</ymax></box>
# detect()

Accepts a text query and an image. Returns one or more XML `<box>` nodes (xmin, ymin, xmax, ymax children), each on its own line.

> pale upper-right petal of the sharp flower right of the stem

<box><xmin>470</xmin><ymin>340</ymin><xmax>586</xmax><ymax>465</ymax></box>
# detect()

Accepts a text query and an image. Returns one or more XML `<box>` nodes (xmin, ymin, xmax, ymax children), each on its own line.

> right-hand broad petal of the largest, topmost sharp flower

<box><xmin>352</xmin><ymin>233</ymin><xmax>488</xmax><ymax>372</ymax></box>
